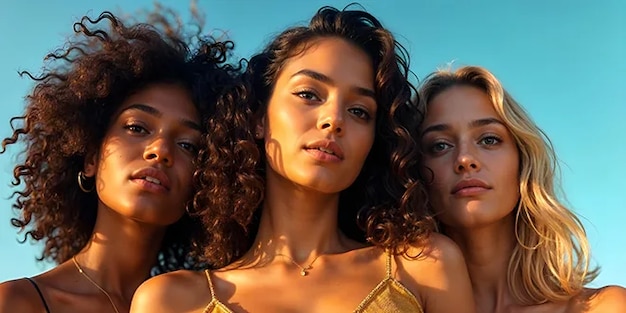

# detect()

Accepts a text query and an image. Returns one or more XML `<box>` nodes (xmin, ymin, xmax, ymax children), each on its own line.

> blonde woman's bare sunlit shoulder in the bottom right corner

<box><xmin>572</xmin><ymin>285</ymin><xmax>626</xmax><ymax>313</ymax></box>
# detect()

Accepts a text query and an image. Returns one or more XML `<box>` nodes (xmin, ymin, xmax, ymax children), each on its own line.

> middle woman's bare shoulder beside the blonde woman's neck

<box><xmin>395</xmin><ymin>233</ymin><xmax>475</xmax><ymax>312</ymax></box>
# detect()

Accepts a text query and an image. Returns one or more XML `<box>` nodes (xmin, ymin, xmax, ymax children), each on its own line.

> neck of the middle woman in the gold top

<box><xmin>249</xmin><ymin>172</ymin><xmax>349</xmax><ymax>263</ymax></box>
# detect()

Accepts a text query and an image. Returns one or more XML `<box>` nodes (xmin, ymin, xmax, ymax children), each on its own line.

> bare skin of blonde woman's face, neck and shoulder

<box><xmin>421</xmin><ymin>85</ymin><xmax>626</xmax><ymax>313</ymax></box>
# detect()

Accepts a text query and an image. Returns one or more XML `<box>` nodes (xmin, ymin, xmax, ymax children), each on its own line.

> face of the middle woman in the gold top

<box><xmin>261</xmin><ymin>38</ymin><xmax>377</xmax><ymax>193</ymax></box>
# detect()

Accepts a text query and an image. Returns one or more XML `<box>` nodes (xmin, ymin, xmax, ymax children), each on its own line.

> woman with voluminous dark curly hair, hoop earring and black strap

<box><xmin>0</xmin><ymin>12</ymin><xmax>238</xmax><ymax>313</ymax></box>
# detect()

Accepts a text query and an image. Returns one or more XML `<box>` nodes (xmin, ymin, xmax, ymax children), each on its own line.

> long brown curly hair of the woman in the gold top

<box><xmin>195</xmin><ymin>7</ymin><xmax>434</xmax><ymax>265</ymax></box>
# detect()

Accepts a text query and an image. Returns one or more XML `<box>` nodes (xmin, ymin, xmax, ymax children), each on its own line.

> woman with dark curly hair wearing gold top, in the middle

<box><xmin>131</xmin><ymin>7</ymin><xmax>474</xmax><ymax>313</ymax></box>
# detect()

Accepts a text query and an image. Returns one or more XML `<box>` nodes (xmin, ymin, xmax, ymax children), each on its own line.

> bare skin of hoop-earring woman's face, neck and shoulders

<box><xmin>0</xmin><ymin>84</ymin><xmax>201</xmax><ymax>313</ymax></box>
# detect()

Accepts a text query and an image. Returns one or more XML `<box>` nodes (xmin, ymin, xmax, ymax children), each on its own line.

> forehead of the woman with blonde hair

<box><xmin>424</xmin><ymin>85</ymin><xmax>498</xmax><ymax>125</ymax></box>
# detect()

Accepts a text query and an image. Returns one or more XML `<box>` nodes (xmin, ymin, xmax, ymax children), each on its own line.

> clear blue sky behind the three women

<box><xmin>0</xmin><ymin>0</ymin><xmax>626</xmax><ymax>286</ymax></box>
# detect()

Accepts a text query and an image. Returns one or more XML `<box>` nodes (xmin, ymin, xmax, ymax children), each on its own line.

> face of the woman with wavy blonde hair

<box><xmin>421</xmin><ymin>86</ymin><xmax>520</xmax><ymax>228</ymax></box>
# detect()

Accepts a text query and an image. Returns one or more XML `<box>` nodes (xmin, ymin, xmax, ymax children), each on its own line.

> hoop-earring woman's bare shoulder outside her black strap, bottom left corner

<box><xmin>0</xmin><ymin>279</ymin><xmax>44</xmax><ymax>313</ymax></box>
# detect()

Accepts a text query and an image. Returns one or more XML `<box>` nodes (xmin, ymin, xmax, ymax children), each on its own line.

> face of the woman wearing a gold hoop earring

<box><xmin>86</xmin><ymin>84</ymin><xmax>201</xmax><ymax>226</ymax></box>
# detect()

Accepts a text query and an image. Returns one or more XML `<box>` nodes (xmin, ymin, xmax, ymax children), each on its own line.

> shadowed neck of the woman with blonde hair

<box><xmin>446</xmin><ymin>214</ymin><xmax>516</xmax><ymax>312</ymax></box>
